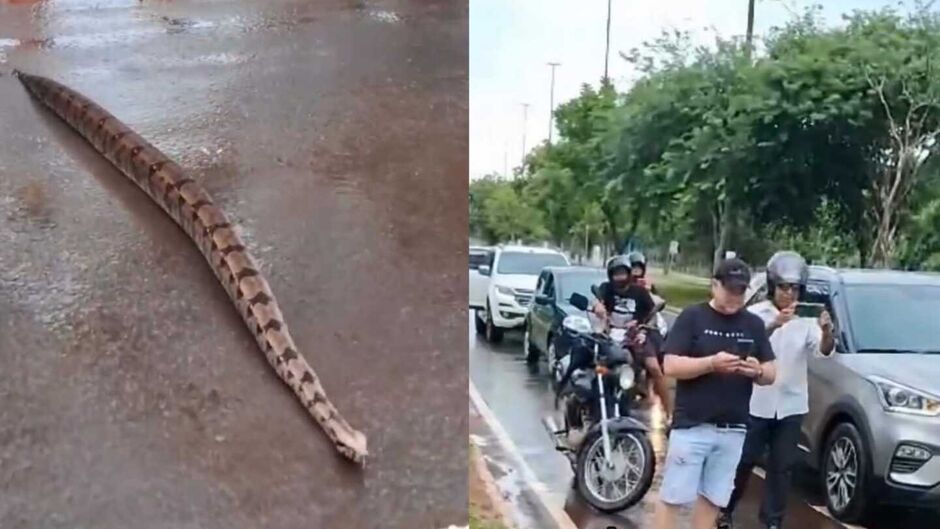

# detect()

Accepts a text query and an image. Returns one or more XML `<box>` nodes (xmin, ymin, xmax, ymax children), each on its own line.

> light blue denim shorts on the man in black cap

<box><xmin>660</xmin><ymin>424</ymin><xmax>747</xmax><ymax>507</ymax></box>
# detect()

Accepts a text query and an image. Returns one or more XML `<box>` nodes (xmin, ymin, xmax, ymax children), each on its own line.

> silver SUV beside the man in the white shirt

<box><xmin>748</xmin><ymin>266</ymin><xmax>940</xmax><ymax>522</ymax></box>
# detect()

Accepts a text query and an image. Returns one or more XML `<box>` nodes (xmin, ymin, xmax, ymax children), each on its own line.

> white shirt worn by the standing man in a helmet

<box><xmin>748</xmin><ymin>301</ymin><xmax>822</xmax><ymax>419</ymax></box>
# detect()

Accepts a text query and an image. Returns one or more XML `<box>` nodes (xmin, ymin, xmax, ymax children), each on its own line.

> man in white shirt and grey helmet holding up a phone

<box><xmin>717</xmin><ymin>251</ymin><xmax>835</xmax><ymax>529</ymax></box>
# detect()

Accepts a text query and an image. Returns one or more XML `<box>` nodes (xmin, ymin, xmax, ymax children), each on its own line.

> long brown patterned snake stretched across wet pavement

<box><xmin>13</xmin><ymin>70</ymin><xmax>368</xmax><ymax>466</ymax></box>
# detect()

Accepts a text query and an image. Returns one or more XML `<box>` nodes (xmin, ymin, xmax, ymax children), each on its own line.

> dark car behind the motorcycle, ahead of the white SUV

<box><xmin>523</xmin><ymin>267</ymin><xmax>607</xmax><ymax>366</ymax></box>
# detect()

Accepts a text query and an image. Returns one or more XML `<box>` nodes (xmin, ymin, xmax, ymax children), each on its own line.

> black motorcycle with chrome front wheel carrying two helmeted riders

<box><xmin>543</xmin><ymin>294</ymin><xmax>656</xmax><ymax>513</ymax></box>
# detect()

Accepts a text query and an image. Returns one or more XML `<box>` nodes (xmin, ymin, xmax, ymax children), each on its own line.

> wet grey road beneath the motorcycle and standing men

<box><xmin>469</xmin><ymin>314</ymin><xmax>940</xmax><ymax>529</ymax></box>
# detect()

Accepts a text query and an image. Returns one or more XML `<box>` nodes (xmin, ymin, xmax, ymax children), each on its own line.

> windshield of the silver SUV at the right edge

<box><xmin>845</xmin><ymin>285</ymin><xmax>940</xmax><ymax>354</ymax></box>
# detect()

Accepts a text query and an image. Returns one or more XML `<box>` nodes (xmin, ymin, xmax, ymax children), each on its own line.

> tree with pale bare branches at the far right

<box><xmin>765</xmin><ymin>6</ymin><xmax>940</xmax><ymax>266</ymax></box>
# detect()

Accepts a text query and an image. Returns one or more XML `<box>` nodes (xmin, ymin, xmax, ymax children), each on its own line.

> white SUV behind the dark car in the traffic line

<box><xmin>470</xmin><ymin>246</ymin><xmax>571</xmax><ymax>343</ymax></box>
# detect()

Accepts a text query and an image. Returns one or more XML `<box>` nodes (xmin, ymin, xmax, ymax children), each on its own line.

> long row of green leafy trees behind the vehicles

<box><xmin>471</xmin><ymin>8</ymin><xmax>940</xmax><ymax>269</ymax></box>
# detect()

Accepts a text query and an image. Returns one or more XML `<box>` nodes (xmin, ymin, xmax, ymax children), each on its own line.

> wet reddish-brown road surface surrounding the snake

<box><xmin>0</xmin><ymin>0</ymin><xmax>468</xmax><ymax>529</ymax></box>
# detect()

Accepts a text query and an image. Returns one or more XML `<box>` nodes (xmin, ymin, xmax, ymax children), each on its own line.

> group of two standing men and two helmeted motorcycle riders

<box><xmin>593</xmin><ymin>251</ymin><xmax>835</xmax><ymax>529</ymax></box>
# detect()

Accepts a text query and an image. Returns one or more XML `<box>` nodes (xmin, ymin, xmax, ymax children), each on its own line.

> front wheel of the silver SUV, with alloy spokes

<box><xmin>820</xmin><ymin>422</ymin><xmax>871</xmax><ymax>523</ymax></box>
